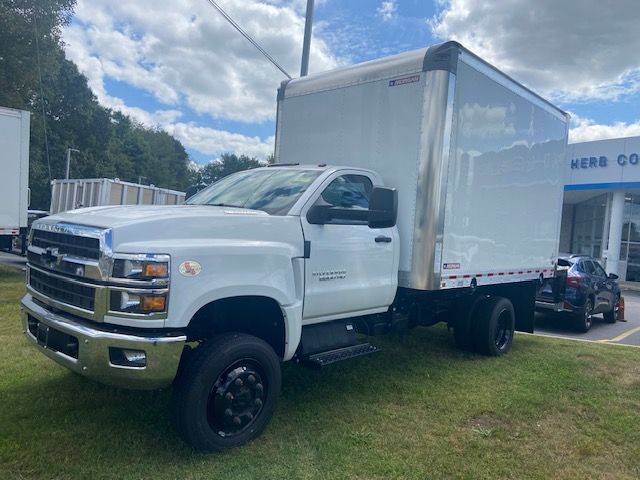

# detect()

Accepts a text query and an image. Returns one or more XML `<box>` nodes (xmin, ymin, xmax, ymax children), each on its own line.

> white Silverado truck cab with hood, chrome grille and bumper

<box><xmin>22</xmin><ymin>165</ymin><xmax>399</xmax><ymax>448</ymax></box>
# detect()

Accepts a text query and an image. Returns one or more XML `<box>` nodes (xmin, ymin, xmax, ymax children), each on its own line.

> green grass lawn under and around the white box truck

<box><xmin>0</xmin><ymin>267</ymin><xmax>640</xmax><ymax>480</ymax></box>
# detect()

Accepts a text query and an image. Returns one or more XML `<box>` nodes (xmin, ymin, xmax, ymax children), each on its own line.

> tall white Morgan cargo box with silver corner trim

<box><xmin>276</xmin><ymin>43</ymin><xmax>567</xmax><ymax>290</ymax></box>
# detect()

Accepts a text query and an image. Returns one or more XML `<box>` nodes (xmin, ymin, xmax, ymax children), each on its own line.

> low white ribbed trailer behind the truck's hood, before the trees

<box><xmin>51</xmin><ymin>178</ymin><xmax>185</xmax><ymax>214</ymax></box>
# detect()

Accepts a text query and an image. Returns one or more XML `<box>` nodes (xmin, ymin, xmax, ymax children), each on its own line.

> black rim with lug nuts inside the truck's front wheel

<box><xmin>207</xmin><ymin>359</ymin><xmax>267</xmax><ymax>437</ymax></box>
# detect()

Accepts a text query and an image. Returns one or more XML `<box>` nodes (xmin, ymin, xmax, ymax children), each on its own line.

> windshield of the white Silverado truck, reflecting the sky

<box><xmin>185</xmin><ymin>169</ymin><xmax>321</xmax><ymax>215</ymax></box>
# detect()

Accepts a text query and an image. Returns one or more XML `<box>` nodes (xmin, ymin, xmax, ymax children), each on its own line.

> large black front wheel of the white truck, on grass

<box><xmin>172</xmin><ymin>333</ymin><xmax>282</xmax><ymax>452</ymax></box>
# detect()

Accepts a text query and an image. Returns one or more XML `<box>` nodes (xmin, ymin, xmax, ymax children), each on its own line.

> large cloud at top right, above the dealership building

<box><xmin>429</xmin><ymin>0</ymin><xmax>640</xmax><ymax>101</ymax></box>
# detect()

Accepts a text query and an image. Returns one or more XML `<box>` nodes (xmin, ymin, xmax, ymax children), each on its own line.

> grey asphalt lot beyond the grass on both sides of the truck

<box><xmin>0</xmin><ymin>252</ymin><xmax>640</xmax><ymax>346</ymax></box>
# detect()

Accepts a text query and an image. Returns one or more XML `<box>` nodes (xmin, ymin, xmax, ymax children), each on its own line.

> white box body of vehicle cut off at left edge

<box><xmin>0</xmin><ymin>107</ymin><xmax>30</xmax><ymax>250</ymax></box>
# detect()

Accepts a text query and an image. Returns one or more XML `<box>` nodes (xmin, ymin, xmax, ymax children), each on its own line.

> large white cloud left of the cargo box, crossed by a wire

<box><xmin>64</xmin><ymin>0</ymin><xmax>338</xmax><ymax>123</ymax></box>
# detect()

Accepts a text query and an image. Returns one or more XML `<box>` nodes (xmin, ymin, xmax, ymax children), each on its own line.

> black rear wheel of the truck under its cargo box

<box><xmin>475</xmin><ymin>297</ymin><xmax>516</xmax><ymax>357</ymax></box>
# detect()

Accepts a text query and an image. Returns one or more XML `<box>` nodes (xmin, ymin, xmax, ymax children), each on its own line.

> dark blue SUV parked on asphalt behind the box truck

<box><xmin>536</xmin><ymin>255</ymin><xmax>620</xmax><ymax>332</ymax></box>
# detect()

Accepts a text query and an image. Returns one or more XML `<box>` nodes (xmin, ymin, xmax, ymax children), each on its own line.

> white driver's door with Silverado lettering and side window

<box><xmin>301</xmin><ymin>172</ymin><xmax>399</xmax><ymax>323</ymax></box>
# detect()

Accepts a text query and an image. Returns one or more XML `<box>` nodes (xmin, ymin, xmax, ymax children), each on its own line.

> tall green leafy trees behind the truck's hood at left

<box><xmin>0</xmin><ymin>0</ymin><xmax>191</xmax><ymax>209</ymax></box>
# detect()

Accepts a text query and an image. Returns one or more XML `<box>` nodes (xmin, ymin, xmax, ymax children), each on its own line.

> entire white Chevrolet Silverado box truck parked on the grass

<box><xmin>22</xmin><ymin>43</ymin><xmax>567</xmax><ymax>451</ymax></box>
